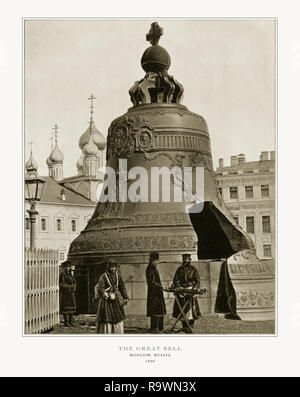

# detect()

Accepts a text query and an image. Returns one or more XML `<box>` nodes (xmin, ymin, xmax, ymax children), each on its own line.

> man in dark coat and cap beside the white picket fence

<box><xmin>59</xmin><ymin>261</ymin><xmax>76</xmax><ymax>327</ymax></box>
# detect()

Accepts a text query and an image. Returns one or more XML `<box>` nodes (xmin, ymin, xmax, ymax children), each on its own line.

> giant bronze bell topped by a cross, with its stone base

<box><xmin>68</xmin><ymin>22</ymin><xmax>273</xmax><ymax>320</ymax></box>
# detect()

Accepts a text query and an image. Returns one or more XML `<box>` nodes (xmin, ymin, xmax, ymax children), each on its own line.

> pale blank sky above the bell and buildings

<box><xmin>24</xmin><ymin>19</ymin><xmax>276</xmax><ymax>177</ymax></box>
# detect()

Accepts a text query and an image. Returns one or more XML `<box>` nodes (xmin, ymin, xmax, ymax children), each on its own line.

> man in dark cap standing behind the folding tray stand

<box><xmin>173</xmin><ymin>254</ymin><xmax>201</xmax><ymax>332</ymax></box>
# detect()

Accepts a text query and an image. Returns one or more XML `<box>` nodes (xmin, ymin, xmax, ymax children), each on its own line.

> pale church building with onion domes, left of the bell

<box><xmin>25</xmin><ymin>95</ymin><xmax>106</xmax><ymax>261</ymax></box>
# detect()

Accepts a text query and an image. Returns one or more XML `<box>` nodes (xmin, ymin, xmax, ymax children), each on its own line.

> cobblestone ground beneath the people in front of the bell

<box><xmin>49</xmin><ymin>315</ymin><xmax>275</xmax><ymax>335</ymax></box>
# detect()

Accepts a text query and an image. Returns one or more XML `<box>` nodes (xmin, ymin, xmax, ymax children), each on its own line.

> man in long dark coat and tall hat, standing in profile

<box><xmin>146</xmin><ymin>252</ymin><xmax>166</xmax><ymax>333</ymax></box>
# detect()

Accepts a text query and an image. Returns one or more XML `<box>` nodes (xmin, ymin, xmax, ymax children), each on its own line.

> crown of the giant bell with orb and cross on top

<box><xmin>129</xmin><ymin>22</ymin><xmax>183</xmax><ymax>106</ymax></box>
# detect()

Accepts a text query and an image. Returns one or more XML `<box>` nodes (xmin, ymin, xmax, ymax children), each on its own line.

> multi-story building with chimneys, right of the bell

<box><xmin>216</xmin><ymin>151</ymin><xmax>276</xmax><ymax>264</ymax></box>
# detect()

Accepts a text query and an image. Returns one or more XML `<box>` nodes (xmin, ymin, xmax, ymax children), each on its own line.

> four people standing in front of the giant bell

<box><xmin>59</xmin><ymin>252</ymin><xmax>201</xmax><ymax>334</ymax></box>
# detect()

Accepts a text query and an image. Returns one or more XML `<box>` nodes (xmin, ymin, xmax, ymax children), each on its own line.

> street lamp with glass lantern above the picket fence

<box><xmin>25</xmin><ymin>172</ymin><xmax>45</xmax><ymax>248</ymax></box>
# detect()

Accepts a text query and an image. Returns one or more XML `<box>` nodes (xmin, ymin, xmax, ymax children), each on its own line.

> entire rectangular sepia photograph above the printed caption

<box><xmin>23</xmin><ymin>18</ymin><xmax>278</xmax><ymax>339</ymax></box>
